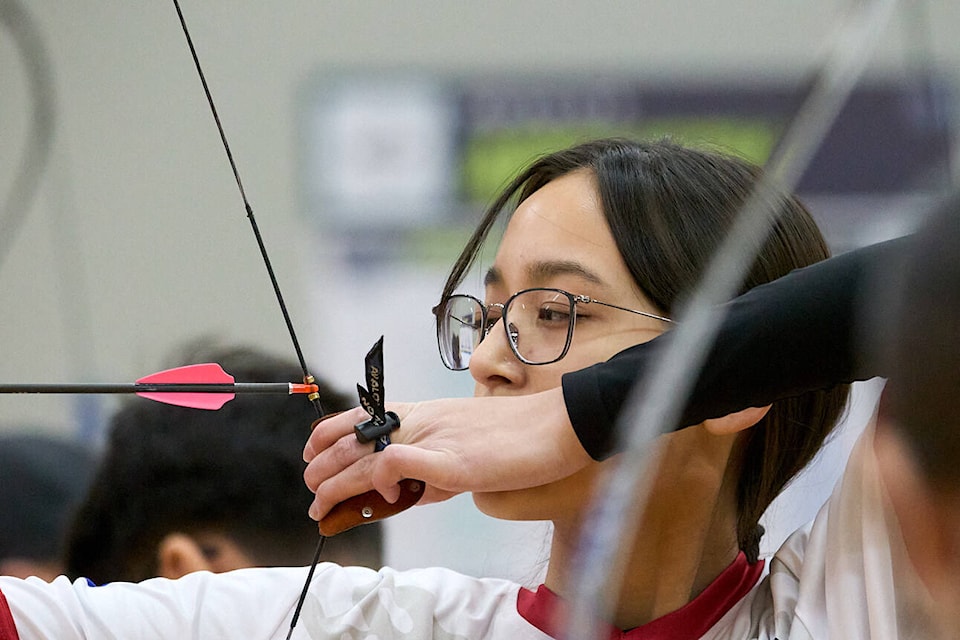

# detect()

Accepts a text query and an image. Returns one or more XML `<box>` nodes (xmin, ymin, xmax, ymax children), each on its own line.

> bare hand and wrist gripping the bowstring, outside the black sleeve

<box><xmin>303</xmin><ymin>387</ymin><xmax>590</xmax><ymax>520</ymax></box>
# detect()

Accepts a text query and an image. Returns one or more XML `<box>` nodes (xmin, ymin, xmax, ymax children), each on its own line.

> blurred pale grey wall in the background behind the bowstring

<box><xmin>0</xmin><ymin>0</ymin><xmax>960</xmax><ymax>577</ymax></box>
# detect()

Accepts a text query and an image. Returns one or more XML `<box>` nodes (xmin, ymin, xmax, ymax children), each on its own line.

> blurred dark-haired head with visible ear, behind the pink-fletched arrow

<box><xmin>66</xmin><ymin>345</ymin><xmax>382</xmax><ymax>584</ymax></box>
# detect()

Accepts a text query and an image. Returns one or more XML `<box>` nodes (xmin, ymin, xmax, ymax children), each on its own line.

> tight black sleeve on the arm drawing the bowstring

<box><xmin>563</xmin><ymin>237</ymin><xmax>909</xmax><ymax>460</ymax></box>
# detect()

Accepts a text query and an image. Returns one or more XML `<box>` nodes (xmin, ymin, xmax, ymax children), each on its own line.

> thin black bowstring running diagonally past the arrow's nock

<box><xmin>173</xmin><ymin>0</ymin><xmax>326</xmax><ymax>640</ymax></box>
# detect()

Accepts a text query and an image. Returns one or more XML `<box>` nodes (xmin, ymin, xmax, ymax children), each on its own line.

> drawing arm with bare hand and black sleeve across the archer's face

<box><xmin>304</xmin><ymin>238</ymin><xmax>907</xmax><ymax>519</ymax></box>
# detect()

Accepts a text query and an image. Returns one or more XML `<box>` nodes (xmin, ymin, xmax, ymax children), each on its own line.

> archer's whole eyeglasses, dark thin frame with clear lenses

<box><xmin>433</xmin><ymin>289</ymin><xmax>673</xmax><ymax>371</ymax></box>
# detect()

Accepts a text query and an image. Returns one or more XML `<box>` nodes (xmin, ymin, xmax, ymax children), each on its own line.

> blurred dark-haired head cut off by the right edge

<box><xmin>871</xmin><ymin>194</ymin><xmax>960</xmax><ymax>637</ymax></box>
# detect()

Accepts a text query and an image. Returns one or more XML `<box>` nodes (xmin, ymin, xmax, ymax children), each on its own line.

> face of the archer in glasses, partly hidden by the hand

<box><xmin>470</xmin><ymin>171</ymin><xmax>666</xmax><ymax>520</ymax></box>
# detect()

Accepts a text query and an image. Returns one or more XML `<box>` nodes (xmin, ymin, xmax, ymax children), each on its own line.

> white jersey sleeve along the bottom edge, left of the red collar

<box><xmin>0</xmin><ymin>563</ymin><xmax>548</xmax><ymax>640</ymax></box>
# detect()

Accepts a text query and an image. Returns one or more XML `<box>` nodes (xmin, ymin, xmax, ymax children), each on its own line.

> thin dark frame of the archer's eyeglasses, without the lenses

<box><xmin>430</xmin><ymin>287</ymin><xmax>673</xmax><ymax>371</ymax></box>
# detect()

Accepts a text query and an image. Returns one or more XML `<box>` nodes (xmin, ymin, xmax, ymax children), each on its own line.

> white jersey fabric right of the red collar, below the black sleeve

<box><xmin>704</xmin><ymin>426</ymin><xmax>933</xmax><ymax>640</ymax></box>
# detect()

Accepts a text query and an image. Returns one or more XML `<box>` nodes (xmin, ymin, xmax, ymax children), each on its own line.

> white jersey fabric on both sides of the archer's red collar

<box><xmin>0</xmin><ymin>420</ymin><xmax>931</xmax><ymax>640</ymax></box>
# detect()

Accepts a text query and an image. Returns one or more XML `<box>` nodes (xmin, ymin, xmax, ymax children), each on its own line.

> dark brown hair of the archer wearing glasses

<box><xmin>443</xmin><ymin>139</ymin><xmax>848</xmax><ymax>561</ymax></box>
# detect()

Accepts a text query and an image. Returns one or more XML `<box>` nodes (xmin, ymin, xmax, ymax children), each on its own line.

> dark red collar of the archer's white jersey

<box><xmin>517</xmin><ymin>551</ymin><xmax>764</xmax><ymax>640</ymax></box>
